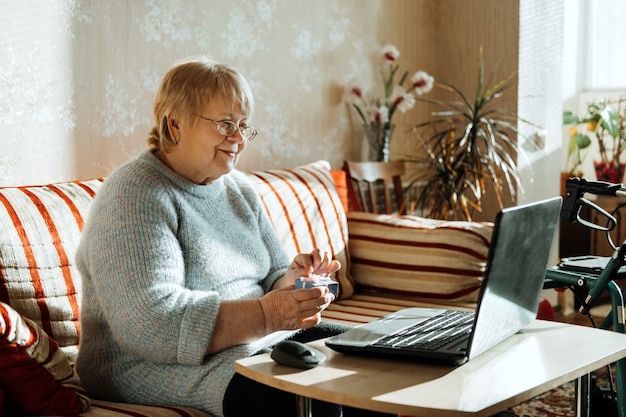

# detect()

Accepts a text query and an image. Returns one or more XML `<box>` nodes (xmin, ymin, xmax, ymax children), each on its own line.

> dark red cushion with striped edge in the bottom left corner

<box><xmin>0</xmin><ymin>303</ymin><xmax>89</xmax><ymax>416</ymax></box>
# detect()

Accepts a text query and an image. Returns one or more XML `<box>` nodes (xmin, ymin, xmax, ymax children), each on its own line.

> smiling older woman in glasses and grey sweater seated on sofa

<box><xmin>77</xmin><ymin>60</ymin><xmax>366</xmax><ymax>417</ymax></box>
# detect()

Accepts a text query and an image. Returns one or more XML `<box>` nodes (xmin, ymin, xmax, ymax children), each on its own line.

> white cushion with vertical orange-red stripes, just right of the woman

<box><xmin>248</xmin><ymin>161</ymin><xmax>354</xmax><ymax>299</ymax></box>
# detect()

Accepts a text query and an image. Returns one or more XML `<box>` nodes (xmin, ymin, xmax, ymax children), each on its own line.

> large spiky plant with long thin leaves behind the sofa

<box><xmin>407</xmin><ymin>53</ymin><xmax>528</xmax><ymax>220</ymax></box>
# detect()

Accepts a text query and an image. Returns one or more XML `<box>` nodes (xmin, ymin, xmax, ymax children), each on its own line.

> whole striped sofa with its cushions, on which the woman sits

<box><xmin>0</xmin><ymin>161</ymin><xmax>492</xmax><ymax>417</ymax></box>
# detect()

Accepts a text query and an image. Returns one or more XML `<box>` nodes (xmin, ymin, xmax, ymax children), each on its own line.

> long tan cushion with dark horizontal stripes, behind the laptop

<box><xmin>347</xmin><ymin>212</ymin><xmax>493</xmax><ymax>302</ymax></box>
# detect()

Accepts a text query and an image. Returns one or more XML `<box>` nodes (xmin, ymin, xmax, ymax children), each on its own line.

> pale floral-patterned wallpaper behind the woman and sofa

<box><xmin>0</xmin><ymin>0</ymin><xmax>402</xmax><ymax>184</ymax></box>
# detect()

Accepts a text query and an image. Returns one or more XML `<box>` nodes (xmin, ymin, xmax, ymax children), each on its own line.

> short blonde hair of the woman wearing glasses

<box><xmin>148</xmin><ymin>58</ymin><xmax>254</xmax><ymax>150</ymax></box>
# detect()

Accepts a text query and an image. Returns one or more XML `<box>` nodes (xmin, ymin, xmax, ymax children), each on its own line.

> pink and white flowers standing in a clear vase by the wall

<box><xmin>345</xmin><ymin>44</ymin><xmax>434</xmax><ymax>161</ymax></box>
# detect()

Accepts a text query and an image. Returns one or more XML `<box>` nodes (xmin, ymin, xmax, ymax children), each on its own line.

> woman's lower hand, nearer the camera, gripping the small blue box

<box><xmin>259</xmin><ymin>287</ymin><xmax>335</xmax><ymax>334</ymax></box>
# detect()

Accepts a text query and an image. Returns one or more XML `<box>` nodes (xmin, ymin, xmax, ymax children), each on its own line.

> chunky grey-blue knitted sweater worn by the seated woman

<box><xmin>76</xmin><ymin>151</ymin><xmax>290</xmax><ymax>416</ymax></box>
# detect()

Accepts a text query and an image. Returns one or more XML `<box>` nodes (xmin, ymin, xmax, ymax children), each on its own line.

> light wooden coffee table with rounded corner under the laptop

<box><xmin>235</xmin><ymin>320</ymin><xmax>626</xmax><ymax>417</ymax></box>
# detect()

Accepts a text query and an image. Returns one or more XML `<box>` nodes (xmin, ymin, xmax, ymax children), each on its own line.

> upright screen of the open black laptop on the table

<box><xmin>469</xmin><ymin>197</ymin><xmax>561</xmax><ymax>359</ymax></box>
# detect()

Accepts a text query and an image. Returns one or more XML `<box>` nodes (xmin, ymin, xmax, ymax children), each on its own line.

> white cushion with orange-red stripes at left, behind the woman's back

<box><xmin>0</xmin><ymin>179</ymin><xmax>102</xmax><ymax>353</ymax></box>
